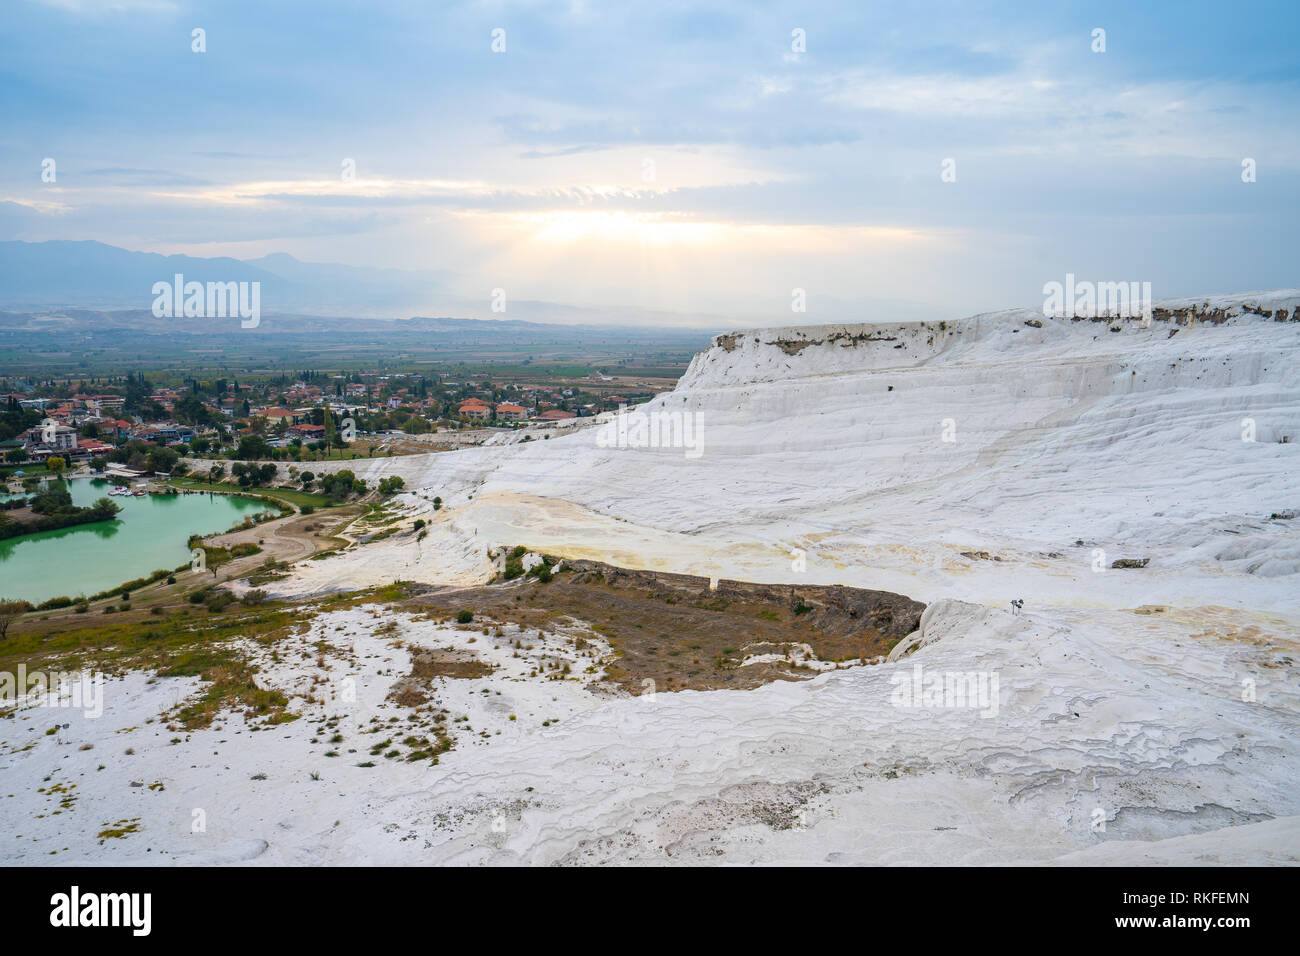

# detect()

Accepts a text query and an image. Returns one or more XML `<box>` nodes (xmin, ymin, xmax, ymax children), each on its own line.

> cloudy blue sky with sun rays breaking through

<box><xmin>0</xmin><ymin>0</ymin><xmax>1300</xmax><ymax>325</ymax></box>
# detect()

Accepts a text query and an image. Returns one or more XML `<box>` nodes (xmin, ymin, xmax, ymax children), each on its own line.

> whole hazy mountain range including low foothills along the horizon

<box><xmin>0</xmin><ymin>239</ymin><xmax>727</xmax><ymax>363</ymax></box>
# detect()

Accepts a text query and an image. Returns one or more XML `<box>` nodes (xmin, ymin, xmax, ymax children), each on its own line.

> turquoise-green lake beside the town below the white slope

<box><xmin>0</xmin><ymin>479</ymin><xmax>274</xmax><ymax>604</ymax></box>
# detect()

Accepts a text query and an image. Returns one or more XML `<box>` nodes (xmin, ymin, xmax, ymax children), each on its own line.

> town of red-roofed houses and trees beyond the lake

<box><xmin>0</xmin><ymin>372</ymin><xmax>657</xmax><ymax>477</ymax></box>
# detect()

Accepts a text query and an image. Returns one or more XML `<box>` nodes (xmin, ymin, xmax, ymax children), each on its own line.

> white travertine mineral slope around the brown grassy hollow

<box><xmin>0</xmin><ymin>290</ymin><xmax>1300</xmax><ymax>865</ymax></box>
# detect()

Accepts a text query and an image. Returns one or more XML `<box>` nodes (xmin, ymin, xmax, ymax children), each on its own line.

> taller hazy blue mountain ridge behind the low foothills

<box><xmin>0</xmin><ymin>239</ymin><xmax>445</xmax><ymax>316</ymax></box>
